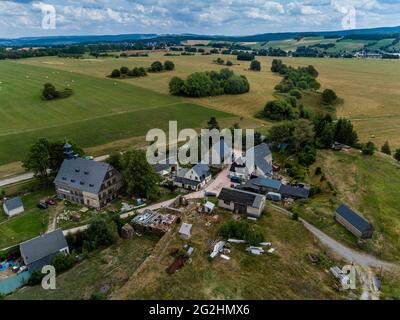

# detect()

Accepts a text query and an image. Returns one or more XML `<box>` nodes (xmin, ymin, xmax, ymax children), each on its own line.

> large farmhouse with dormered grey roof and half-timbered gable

<box><xmin>54</xmin><ymin>144</ymin><xmax>122</xmax><ymax>209</ymax></box>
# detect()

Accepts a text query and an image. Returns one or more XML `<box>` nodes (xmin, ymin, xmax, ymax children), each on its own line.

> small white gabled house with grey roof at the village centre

<box><xmin>173</xmin><ymin>163</ymin><xmax>211</xmax><ymax>190</ymax></box>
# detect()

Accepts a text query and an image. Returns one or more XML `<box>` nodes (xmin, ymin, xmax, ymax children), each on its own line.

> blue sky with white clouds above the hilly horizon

<box><xmin>0</xmin><ymin>0</ymin><xmax>400</xmax><ymax>38</ymax></box>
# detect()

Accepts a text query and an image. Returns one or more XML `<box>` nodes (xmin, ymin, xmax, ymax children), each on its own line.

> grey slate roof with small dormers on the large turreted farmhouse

<box><xmin>54</xmin><ymin>158</ymin><xmax>111</xmax><ymax>193</ymax></box>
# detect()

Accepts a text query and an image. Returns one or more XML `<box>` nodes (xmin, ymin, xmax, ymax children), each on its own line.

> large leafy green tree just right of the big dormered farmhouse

<box><xmin>121</xmin><ymin>150</ymin><xmax>160</xmax><ymax>200</ymax></box>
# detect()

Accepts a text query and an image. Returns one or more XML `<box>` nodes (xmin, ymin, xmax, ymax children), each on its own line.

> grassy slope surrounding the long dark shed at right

<box><xmin>295</xmin><ymin>150</ymin><xmax>400</xmax><ymax>261</ymax></box>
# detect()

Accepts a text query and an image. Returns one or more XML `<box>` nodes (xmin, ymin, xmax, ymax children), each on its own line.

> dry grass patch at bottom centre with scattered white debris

<box><xmin>113</xmin><ymin>212</ymin><xmax>343</xmax><ymax>300</ymax></box>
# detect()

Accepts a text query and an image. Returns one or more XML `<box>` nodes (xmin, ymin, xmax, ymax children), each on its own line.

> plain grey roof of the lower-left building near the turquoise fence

<box><xmin>19</xmin><ymin>229</ymin><xmax>68</xmax><ymax>264</ymax></box>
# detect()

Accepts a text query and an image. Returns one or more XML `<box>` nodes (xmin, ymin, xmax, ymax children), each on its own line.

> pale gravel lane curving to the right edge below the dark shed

<box><xmin>271</xmin><ymin>205</ymin><xmax>399</xmax><ymax>270</ymax></box>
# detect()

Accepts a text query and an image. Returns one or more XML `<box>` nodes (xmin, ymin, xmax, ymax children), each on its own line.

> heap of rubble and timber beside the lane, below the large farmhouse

<box><xmin>132</xmin><ymin>209</ymin><xmax>177</xmax><ymax>233</ymax></box>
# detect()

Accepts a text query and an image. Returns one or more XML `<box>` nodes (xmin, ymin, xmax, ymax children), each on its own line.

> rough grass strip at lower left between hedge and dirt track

<box><xmin>8</xmin><ymin>232</ymin><xmax>158</xmax><ymax>300</ymax></box>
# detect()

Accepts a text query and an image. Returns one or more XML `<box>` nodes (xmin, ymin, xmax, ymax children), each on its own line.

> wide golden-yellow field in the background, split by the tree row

<box><xmin>19</xmin><ymin>53</ymin><xmax>400</xmax><ymax>148</ymax></box>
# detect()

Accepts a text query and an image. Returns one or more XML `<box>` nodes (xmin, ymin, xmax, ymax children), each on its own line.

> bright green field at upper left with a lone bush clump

<box><xmin>0</xmin><ymin>61</ymin><xmax>234</xmax><ymax>165</ymax></box>
